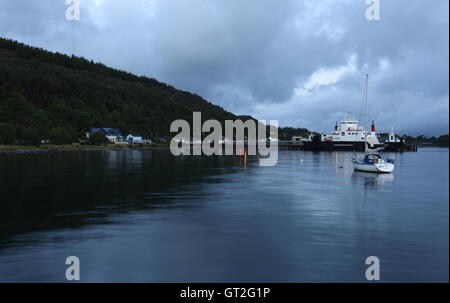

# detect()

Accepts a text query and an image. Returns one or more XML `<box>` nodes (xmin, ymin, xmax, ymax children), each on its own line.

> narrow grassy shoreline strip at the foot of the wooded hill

<box><xmin>0</xmin><ymin>144</ymin><xmax>169</xmax><ymax>155</ymax></box>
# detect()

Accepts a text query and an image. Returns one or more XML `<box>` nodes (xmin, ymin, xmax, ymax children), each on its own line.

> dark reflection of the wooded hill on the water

<box><xmin>0</xmin><ymin>150</ymin><xmax>239</xmax><ymax>248</ymax></box>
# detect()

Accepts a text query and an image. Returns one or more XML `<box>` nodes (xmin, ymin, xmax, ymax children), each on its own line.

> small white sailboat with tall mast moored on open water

<box><xmin>352</xmin><ymin>75</ymin><xmax>395</xmax><ymax>173</ymax></box>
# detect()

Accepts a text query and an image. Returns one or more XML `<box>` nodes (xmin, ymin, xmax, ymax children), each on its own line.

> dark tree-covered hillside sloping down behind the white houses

<box><xmin>0</xmin><ymin>38</ymin><xmax>246</xmax><ymax>144</ymax></box>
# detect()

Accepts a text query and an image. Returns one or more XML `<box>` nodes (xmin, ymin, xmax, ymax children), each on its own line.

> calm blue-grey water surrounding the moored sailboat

<box><xmin>0</xmin><ymin>148</ymin><xmax>449</xmax><ymax>282</ymax></box>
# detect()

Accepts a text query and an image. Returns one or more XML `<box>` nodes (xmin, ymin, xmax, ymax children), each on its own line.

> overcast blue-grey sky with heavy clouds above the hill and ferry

<box><xmin>0</xmin><ymin>0</ymin><xmax>449</xmax><ymax>135</ymax></box>
